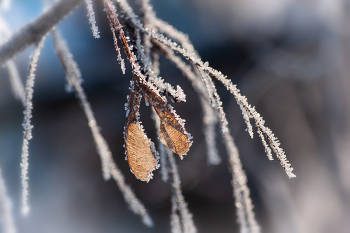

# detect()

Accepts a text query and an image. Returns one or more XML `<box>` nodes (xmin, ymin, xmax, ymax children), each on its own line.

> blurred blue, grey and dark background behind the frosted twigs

<box><xmin>0</xmin><ymin>0</ymin><xmax>350</xmax><ymax>233</ymax></box>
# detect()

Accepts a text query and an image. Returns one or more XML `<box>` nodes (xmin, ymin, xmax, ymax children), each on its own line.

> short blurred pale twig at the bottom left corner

<box><xmin>0</xmin><ymin>170</ymin><xmax>17</xmax><ymax>233</ymax></box>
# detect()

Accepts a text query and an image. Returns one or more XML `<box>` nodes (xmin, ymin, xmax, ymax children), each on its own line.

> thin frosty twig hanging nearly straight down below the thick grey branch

<box><xmin>21</xmin><ymin>36</ymin><xmax>45</xmax><ymax>215</ymax></box>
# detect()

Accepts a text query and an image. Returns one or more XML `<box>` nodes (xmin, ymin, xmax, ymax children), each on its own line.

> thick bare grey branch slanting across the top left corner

<box><xmin>0</xmin><ymin>0</ymin><xmax>82</xmax><ymax>65</ymax></box>
